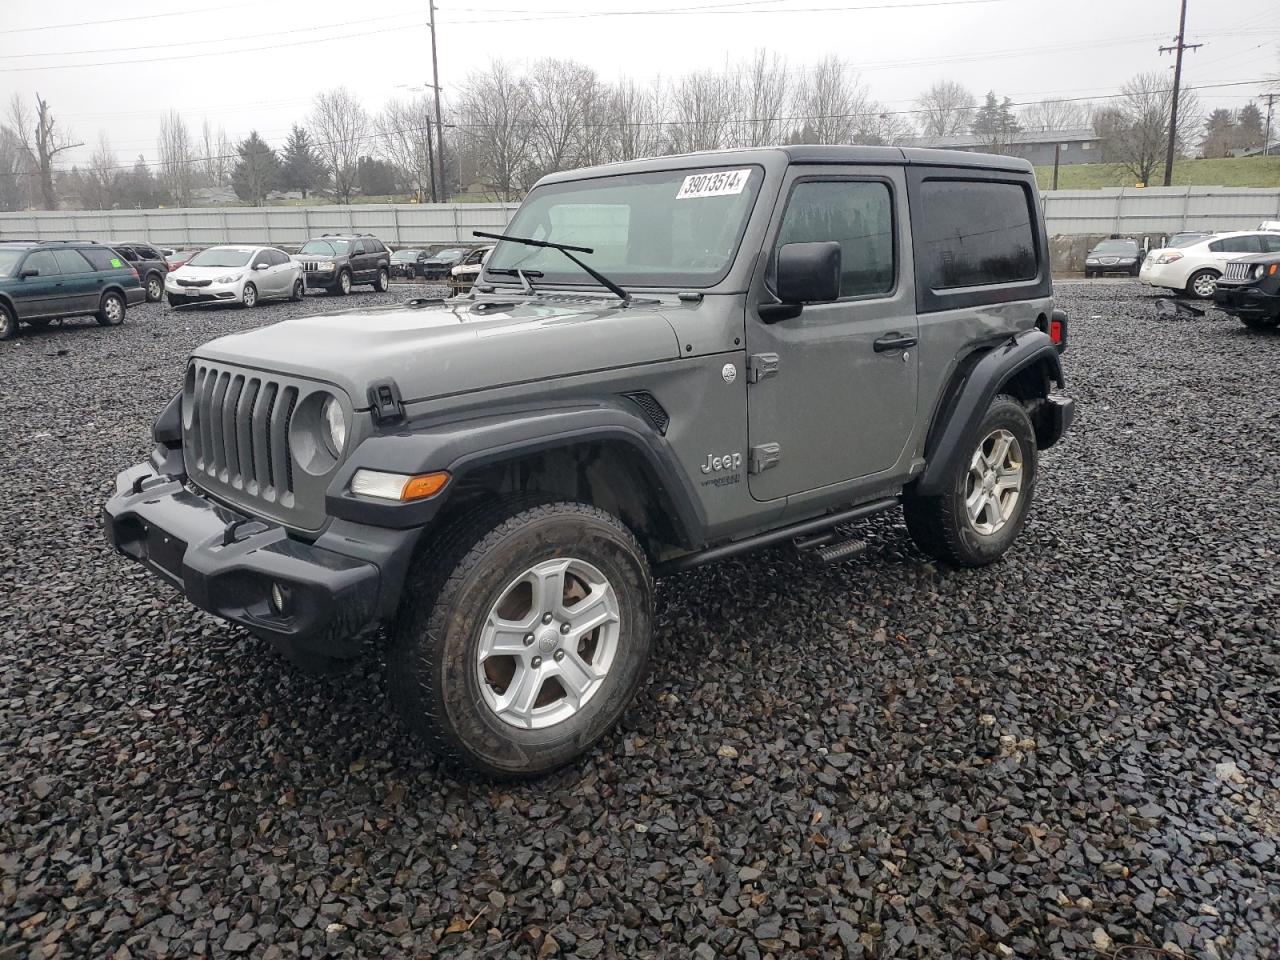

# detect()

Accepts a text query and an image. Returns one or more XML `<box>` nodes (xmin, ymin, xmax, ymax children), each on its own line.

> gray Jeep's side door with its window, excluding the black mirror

<box><xmin>746</xmin><ymin>166</ymin><xmax>918</xmax><ymax>500</ymax></box>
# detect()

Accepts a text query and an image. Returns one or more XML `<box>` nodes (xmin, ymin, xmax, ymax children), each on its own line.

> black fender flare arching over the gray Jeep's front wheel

<box><xmin>325</xmin><ymin>399</ymin><xmax>707</xmax><ymax>544</ymax></box>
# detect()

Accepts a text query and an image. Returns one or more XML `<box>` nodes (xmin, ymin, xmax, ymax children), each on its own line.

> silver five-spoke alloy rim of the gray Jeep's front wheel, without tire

<box><xmin>476</xmin><ymin>557</ymin><xmax>622</xmax><ymax>730</ymax></box>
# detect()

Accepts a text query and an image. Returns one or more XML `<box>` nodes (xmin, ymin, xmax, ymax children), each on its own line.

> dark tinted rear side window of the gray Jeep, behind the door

<box><xmin>913</xmin><ymin>180</ymin><xmax>1038</xmax><ymax>289</ymax></box>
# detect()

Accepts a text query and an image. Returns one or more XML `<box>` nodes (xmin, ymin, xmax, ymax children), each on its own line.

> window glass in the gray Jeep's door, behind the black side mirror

<box><xmin>774</xmin><ymin>180</ymin><xmax>895</xmax><ymax>297</ymax></box>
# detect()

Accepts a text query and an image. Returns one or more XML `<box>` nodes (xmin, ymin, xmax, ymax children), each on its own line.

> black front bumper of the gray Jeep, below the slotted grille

<box><xmin>102</xmin><ymin>463</ymin><xmax>417</xmax><ymax>657</ymax></box>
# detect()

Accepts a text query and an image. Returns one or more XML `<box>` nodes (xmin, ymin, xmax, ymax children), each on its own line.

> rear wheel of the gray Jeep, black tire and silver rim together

<box><xmin>902</xmin><ymin>394</ymin><xmax>1037</xmax><ymax>567</ymax></box>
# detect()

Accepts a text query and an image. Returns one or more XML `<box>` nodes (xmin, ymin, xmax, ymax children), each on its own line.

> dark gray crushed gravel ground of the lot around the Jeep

<box><xmin>0</xmin><ymin>282</ymin><xmax>1280</xmax><ymax>960</ymax></box>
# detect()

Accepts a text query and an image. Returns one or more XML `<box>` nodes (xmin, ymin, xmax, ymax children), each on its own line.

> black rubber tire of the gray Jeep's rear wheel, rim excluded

<box><xmin>902</xmin><ymin>394</ymin><xmax>1038</xmax><ymax>567</ymax></box>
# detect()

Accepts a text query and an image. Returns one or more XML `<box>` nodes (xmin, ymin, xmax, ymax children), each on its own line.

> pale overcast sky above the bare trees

<box><xmin>0</xmin><ymin>0</ymin><xmax>1280</xmax><ymax>166</ymax></box>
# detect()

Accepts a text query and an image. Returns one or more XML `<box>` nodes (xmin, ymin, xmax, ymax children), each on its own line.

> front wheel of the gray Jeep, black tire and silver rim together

<box><xmin>388</xmin><ymin>502</ymin><xmax>653</xmax><ymax>777</ymax></box>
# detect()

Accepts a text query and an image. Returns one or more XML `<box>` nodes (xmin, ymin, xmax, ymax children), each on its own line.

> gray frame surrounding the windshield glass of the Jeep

<box><xmin>479</xmin><ymin>165</ymin><xmax>776</xmax><ymax>291</ymax></box>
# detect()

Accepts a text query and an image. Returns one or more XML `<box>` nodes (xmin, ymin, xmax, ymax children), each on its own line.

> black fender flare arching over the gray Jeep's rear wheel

<box><xmin>915</xmin><ymin>330</ymin><xmax>1064</xmax><ymax>497</ymax></box>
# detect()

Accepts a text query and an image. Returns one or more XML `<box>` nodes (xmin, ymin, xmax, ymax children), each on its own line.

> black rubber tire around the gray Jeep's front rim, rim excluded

<box><xmin>387</xmin><ymin>499</ymin><xmax>653</xmax><ymax>778</ymax></box>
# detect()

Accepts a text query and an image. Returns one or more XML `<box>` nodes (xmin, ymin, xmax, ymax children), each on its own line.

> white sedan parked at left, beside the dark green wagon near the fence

<box><xmin>164</xmin><ymin>246</ymin><xmax>306</xmax><ymax>307</ymax></box>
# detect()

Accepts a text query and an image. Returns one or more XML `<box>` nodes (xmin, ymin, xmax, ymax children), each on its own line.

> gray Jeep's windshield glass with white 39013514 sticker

<box><xmin>485</xmin><ymin>166</ymin><xmax>764</xmax><ymax>287</ymax></box>
